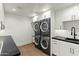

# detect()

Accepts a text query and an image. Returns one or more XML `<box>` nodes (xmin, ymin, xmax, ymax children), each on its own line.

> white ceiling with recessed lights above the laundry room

<box><xmin>3</xmin><ymin>3</ymin><xmax>73</xmax><ymax>17</ymax></box>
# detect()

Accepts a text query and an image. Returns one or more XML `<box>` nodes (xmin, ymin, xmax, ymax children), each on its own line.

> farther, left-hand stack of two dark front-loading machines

<box><xmin>33</xmin><ymin>21</ymin><xmax>41</xmax><ymax>49</ymax></box>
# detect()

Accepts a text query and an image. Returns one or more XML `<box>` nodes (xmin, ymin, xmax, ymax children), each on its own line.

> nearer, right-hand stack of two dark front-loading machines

<box><xmin>40</xmin><ymin>18</ymin><xmax>50</xmax><ymax>55</ymax></box>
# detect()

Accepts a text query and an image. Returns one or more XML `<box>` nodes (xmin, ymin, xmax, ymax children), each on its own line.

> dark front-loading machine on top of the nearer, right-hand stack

<box><xmin>40</xmin><ymin>18</ymin><xmax>50</xmax><ymax>36</ymax></box>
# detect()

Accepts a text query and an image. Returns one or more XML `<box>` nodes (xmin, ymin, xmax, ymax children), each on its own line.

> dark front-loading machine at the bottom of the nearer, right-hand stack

<box><xmin>40</xmin><ymin>36</ymin><xmax>50</xmax><ymax>55</ymax></box>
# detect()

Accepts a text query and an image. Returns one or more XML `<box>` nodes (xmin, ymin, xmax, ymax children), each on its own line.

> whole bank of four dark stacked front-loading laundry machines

<box><xmin>34</xmin><ymin>18</ymin><xmax>50</xmax><ymax>55</ymax></box>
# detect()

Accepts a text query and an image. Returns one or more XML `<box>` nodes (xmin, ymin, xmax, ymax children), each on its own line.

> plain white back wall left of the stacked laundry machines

<box><xmin>5</xmin><ymin>13</ymin><xmax>33</xmax><ymax>46</ymax></box>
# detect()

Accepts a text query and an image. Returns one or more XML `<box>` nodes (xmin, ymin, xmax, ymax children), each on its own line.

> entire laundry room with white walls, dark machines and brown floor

<box><xmin>0</xmin><ymin>3</ymin><xmax>79</xmax><ymax>56</ymax></box>
